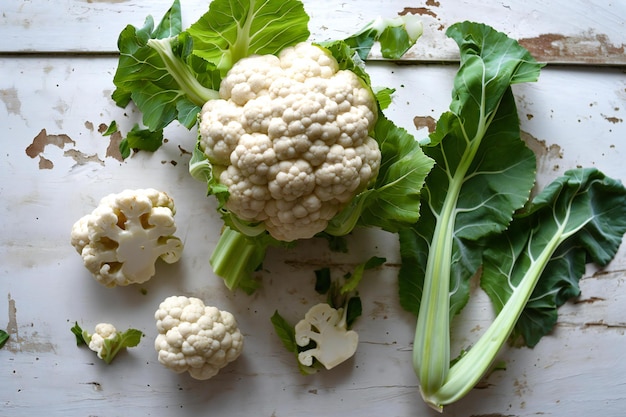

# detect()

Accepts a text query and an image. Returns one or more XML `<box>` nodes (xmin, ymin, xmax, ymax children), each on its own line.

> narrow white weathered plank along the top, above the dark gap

<box><xmin>0</xmin><ymin>0</ymin><xmax>626</xmax><ymax>65</ymax></box>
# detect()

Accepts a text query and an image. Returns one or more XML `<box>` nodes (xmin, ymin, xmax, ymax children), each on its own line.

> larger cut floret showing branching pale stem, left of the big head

<box><xmin>71</xmin><ymin>188</ymin><xmax>183</xmax><ymax>287</ymax></box>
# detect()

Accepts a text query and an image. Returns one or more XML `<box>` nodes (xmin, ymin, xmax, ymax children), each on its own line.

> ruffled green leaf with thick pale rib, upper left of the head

<box><xmin>113</xmin><ymin>0</ymin><xmax>217</xmax><ymax>131</ymax></box>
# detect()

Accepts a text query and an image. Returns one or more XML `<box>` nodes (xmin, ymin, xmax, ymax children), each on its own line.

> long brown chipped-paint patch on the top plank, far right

<box><xmin>519</xmin><ymin>30</ymin><xmax>626</xmax><ymax>64</ymax></box>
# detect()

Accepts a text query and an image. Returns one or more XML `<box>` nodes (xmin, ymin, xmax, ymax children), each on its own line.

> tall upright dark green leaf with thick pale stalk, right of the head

<box><xmin>399</xmin><ymin>22</ymin><xmax>541</xmax><ymax>398</ymax></box>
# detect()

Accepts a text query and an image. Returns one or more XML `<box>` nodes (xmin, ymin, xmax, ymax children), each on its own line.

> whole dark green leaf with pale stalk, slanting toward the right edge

<box><xmin>425</xmin><ymin>168</ymin><xmax>626</xmax><ymax>408</ymax></box>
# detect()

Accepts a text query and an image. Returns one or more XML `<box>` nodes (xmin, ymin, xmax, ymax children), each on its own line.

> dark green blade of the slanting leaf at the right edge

<box><xmin>481</xmin><ymin>168</ymin><xmax>626</xmax><ymax>347</ymax></box>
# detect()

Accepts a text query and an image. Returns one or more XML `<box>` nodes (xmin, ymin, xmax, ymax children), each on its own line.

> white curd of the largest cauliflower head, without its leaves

<box><xmin>199</xmin><ymin>42</ymin><xmax>381</xmax><ymax>241</ymax></box>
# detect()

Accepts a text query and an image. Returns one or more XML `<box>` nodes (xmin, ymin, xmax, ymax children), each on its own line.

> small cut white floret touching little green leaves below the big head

<box><xmin>295</xmin><ymin>303</ymin><xmax>359</xmax><ymax>369</ymax></box>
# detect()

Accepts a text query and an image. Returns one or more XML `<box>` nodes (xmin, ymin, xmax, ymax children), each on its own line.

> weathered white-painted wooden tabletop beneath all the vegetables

<box><xmin>0</xmin><ymin>0</ymin><xmax>626</xmax><ymax>417</ymax></box>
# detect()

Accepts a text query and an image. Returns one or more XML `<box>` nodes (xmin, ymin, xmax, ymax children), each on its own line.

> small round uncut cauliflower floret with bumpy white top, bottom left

<box><xmin>154</xmin><ymin>296</ymin><xmax>243</xmax><ymax>380</ymax></box>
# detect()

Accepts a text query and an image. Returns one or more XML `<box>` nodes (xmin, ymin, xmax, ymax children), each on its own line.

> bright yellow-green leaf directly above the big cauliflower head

<box><xmin>188</xmin><ymin>0</ymin><xmax>309</xmax><ymax>72</ymax></box>
